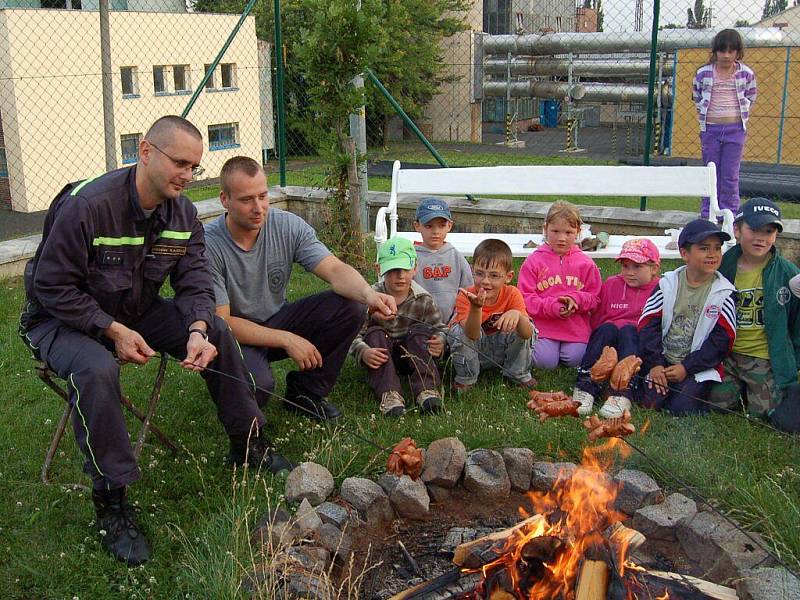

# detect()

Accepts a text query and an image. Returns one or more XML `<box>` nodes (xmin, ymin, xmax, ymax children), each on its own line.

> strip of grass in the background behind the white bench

<box><xmin>264</xmin><ymin>144</ymin><xmax>800</xmax><ymax>219</ymax></box>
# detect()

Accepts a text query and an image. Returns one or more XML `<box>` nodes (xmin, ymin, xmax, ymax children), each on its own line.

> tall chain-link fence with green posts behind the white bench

<box><xmin>0</xmin><ymin>0</ymin><xmax>800</xmax><ymax>216</ymax></box>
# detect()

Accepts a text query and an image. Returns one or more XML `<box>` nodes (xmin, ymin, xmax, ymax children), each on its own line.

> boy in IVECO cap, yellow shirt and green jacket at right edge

<box><xmin>709</xmin><ymin>198</ymin><xmax>800</xmax><ymax>416</ymax></box>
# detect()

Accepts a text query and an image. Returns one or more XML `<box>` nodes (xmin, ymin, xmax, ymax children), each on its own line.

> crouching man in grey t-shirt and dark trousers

<box><xmin>206</xmin><ymin>156</ymin><xmax>397</xmax><ymax>420</ymax></box>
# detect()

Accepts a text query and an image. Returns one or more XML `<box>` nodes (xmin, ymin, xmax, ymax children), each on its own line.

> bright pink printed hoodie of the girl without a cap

<box><xmin>518</xmin><ymin>244</ymin><xmax>602</xmax><ymax>344</ymax></box>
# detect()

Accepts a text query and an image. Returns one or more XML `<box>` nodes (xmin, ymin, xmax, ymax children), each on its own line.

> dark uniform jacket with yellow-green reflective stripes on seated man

<box><xmin>21</xmin><ymin>166</ymin><xmax>214</xmax><ymax>336</ymax></box>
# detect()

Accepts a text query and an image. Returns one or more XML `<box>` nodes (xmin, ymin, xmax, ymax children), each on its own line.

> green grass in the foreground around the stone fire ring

<box><xmin>0</xmin><ymin>261</ymin><xmax>800</xmax><ymax>600</ymax></box>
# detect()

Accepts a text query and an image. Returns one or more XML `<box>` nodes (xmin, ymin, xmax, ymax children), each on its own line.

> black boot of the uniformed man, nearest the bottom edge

<box><xmin>92</xmin><ymin>487</ymin><xmax>152</xmax><ymax>567</ymax></box>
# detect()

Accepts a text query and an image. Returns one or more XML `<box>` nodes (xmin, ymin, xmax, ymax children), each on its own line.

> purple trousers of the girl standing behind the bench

<box><xmin>700</xmin><ymin>123</ymin><xmax>747</xmax><ymax>218</ymax></box>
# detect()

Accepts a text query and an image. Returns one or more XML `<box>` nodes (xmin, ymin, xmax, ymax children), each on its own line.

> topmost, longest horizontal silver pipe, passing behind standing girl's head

<box><xmin>483</xmin><ymin>27</ymin><xmax>800</xmax><ymax>56</ymax></box>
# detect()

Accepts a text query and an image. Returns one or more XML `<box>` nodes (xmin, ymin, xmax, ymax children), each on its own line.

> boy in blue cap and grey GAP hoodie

<box><xmin>414</xmin><ymin>197</ymin><xmax>474</xmax><ymax>321</ymax></box>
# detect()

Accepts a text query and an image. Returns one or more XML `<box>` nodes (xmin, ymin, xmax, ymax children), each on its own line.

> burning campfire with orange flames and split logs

<box><xmin>393</xmin><ymin>439</ymin><xmax>736</xmax><ymax>600</ymax></box>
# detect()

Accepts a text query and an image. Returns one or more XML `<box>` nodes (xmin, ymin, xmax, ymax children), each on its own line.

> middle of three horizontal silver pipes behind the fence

<box><xmin>483</xmin><ymin>57</ymin><xmax>672</xmax><ymax>78</ymax></box>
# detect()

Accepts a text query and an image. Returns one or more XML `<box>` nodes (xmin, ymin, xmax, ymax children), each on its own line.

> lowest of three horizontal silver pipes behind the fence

<box><xmin>483</xmin><ymin>81</ymin><xmax>672</xmax><ymax>106</ymax></box>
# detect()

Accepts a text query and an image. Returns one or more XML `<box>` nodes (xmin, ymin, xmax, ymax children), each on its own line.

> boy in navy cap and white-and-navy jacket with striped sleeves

<box><xmin>639</xmin><ymin>219</ymin><xmax>736</xmax><ymax>415</ymax></box>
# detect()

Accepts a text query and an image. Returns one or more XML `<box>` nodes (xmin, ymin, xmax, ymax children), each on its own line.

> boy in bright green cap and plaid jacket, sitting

<box><xmin>350</xmin><ymin>238</ymin><xmax>445</xmax><ymax>417</ymax></box>
